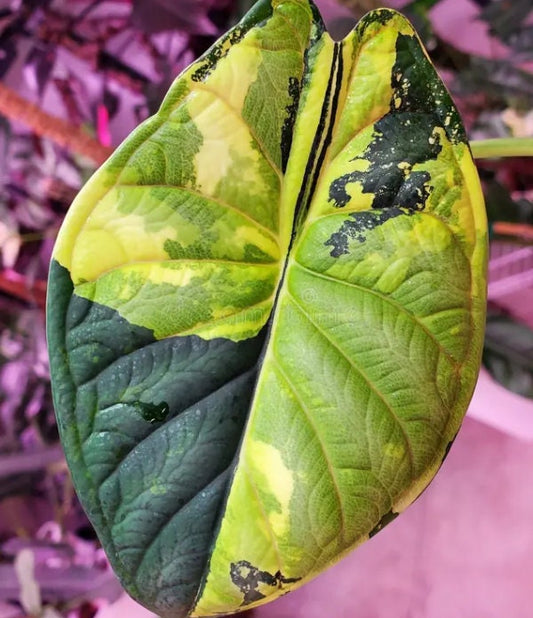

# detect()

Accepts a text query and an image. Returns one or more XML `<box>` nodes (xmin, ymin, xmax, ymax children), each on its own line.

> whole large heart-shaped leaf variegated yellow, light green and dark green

<box><xmin>48</xmin><ymin>0</ymin><xmax>487</xmax><ymax>617</ymax></box>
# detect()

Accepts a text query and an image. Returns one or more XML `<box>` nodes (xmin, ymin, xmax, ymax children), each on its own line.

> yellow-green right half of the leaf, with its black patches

<box><xmin>193</xmin><ymin>11</ymin><xmax>487</xmax><ymax>616</ymax></box>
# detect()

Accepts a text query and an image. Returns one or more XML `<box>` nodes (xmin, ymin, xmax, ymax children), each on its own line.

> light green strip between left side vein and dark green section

<box><xmin>77</xmin><ymin>259</ymin><xmax>278</xmax><ymax>339</ymax></box>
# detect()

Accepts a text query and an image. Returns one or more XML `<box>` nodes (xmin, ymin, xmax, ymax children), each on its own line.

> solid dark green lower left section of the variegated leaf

<box><xmin>48</xmin><ymin>261</ymin><xmax>263</xmax><ymax>616</ymax></box>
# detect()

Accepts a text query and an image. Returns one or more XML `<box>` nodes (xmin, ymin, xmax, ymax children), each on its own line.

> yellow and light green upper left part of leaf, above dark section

<box><xmin>54</xmin><ymin>1</ymin><xmax>312</xmax><ymax>341</ymax></box>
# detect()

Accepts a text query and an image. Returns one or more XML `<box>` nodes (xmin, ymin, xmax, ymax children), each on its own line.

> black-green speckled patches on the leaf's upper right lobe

<box><xmin>325</xmin><ymin>29</ymin><xmax>466</xmax><ymax>257</ymax></box>
